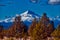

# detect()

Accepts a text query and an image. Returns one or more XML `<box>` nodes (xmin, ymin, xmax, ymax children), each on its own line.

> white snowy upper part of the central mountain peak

<box><xmin>20</xmin><ymin>11</ymin><xmax>40</xmax><ymax>22</ymax></box>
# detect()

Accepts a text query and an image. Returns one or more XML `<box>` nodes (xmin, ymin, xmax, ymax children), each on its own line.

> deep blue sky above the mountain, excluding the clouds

<box><xmin>0</xmin><ymin>0</ymin><xmax>60</xmax><ymax>20</ymax></box>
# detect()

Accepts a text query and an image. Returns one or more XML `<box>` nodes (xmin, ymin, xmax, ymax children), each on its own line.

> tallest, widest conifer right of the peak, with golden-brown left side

<box><xmin>31</xmin><ymin>13</ymin><xmax>53</xmax><ymax>40</ymax></box>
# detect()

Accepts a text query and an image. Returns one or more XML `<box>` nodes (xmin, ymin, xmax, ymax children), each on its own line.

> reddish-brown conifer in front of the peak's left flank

<box><xmin>15</xmin><ymin>16</ymin><xmax>26</xmax><ymax>37</ymax></box>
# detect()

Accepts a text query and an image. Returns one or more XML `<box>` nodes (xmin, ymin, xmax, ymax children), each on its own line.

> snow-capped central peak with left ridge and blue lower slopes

<box><xmin>0</xmin><ymin>11</ymin><xmax>40</xmax><ymax>27</ymax></box>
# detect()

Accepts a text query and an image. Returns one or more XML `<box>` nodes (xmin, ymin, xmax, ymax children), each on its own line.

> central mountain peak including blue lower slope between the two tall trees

<box><xmin>17</xmin><ymin>11</ymin><xmax>40</xmax><ymax>26</ymax></box>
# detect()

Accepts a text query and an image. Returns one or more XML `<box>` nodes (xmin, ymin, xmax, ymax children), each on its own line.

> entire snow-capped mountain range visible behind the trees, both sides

<box><xmin>0</xmin><ymin>11</ymin><xmax>60</xmax><ymax>28</ymax></box>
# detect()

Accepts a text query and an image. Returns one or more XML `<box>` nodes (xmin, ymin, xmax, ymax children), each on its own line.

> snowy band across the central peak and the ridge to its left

<box><xmin>0</xmin><ymin>11</ymin><xmax>40</xmax><ymax>23</ymax></box>
